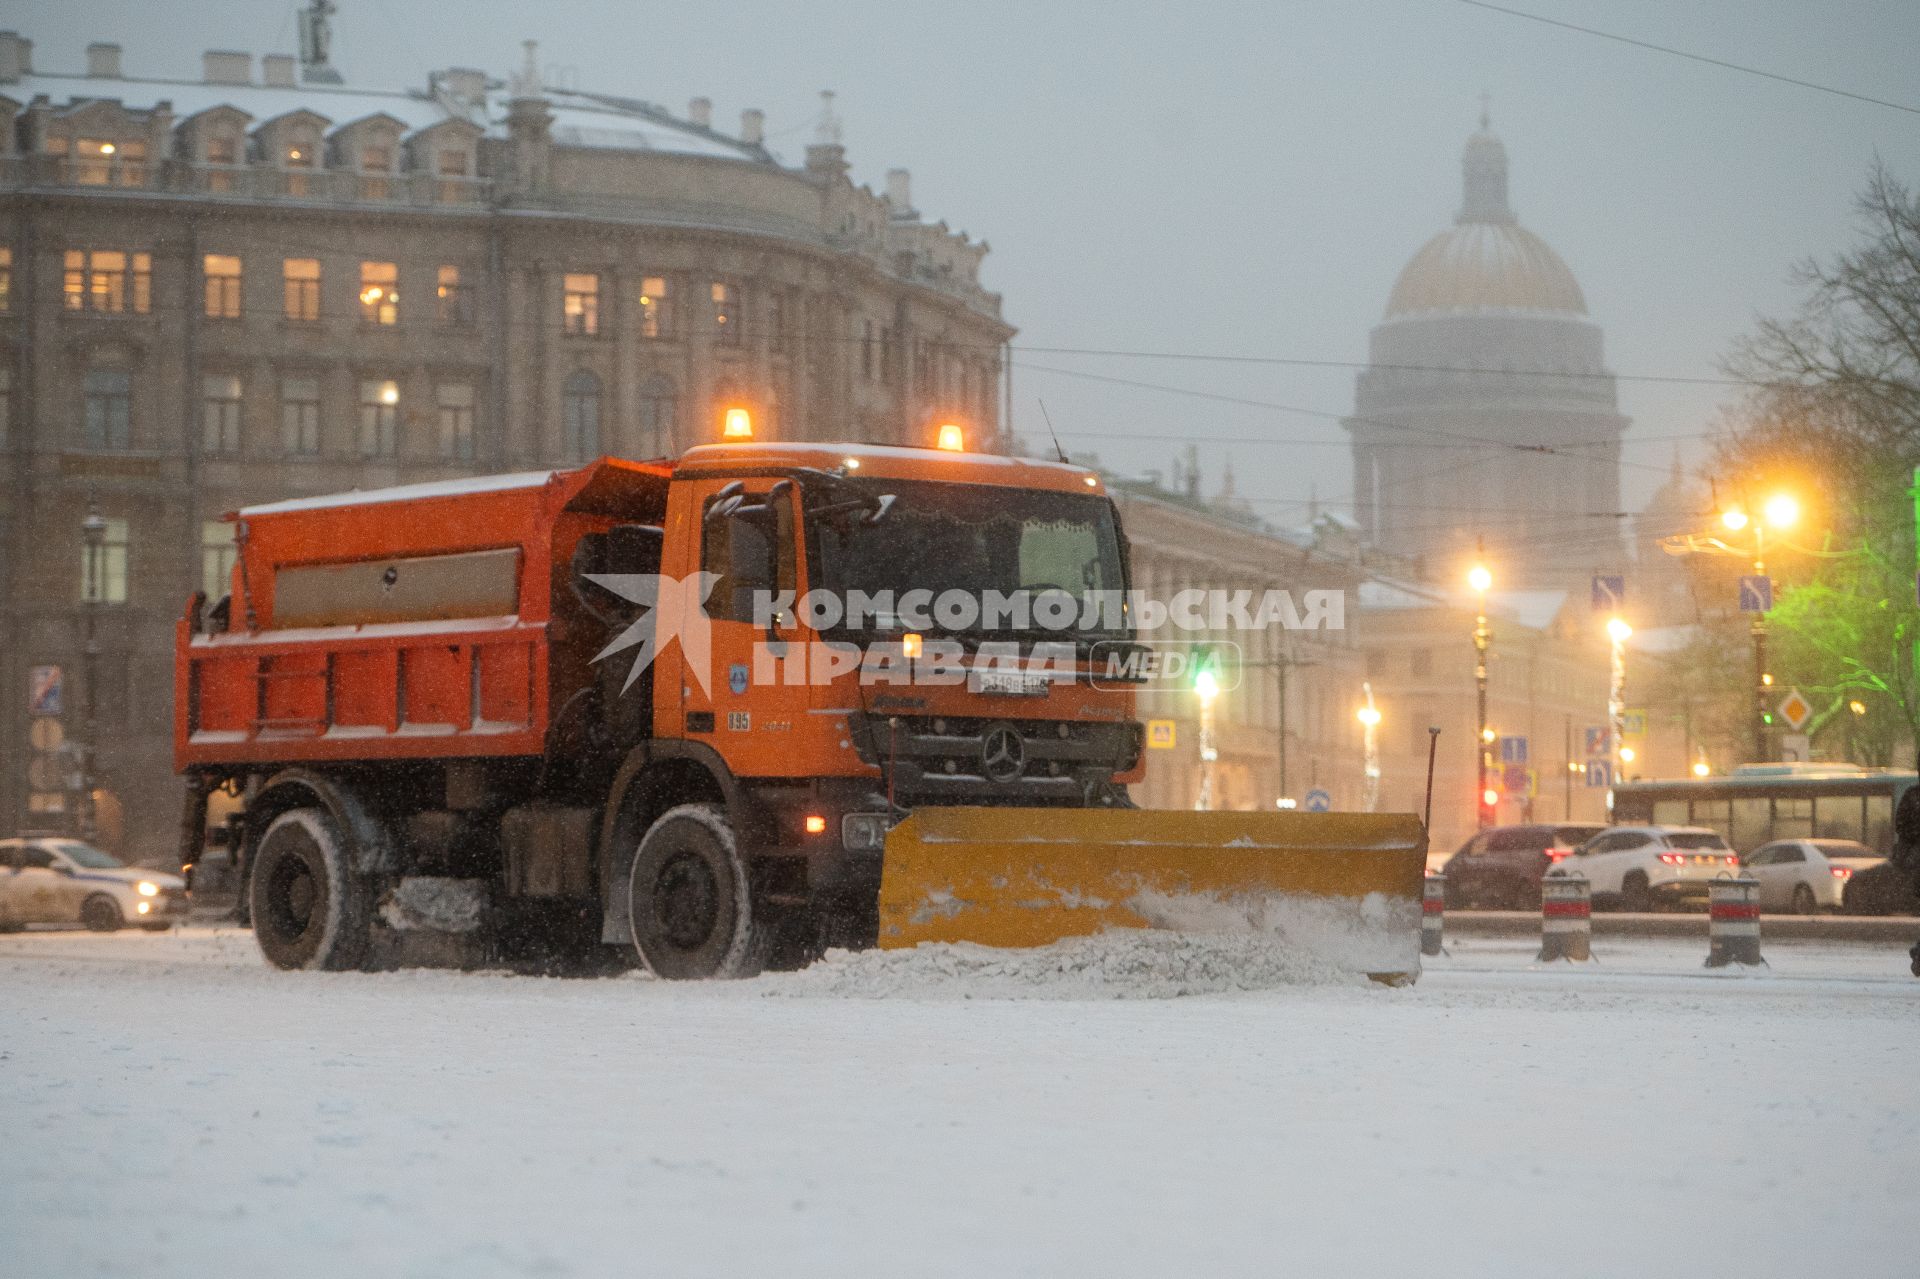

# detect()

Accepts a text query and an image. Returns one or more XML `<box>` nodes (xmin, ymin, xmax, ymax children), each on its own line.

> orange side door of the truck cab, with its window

<box><xmin>680</xmin><ymin>476</ymin><xmax>808</xmax><ymax>776</ymax></box>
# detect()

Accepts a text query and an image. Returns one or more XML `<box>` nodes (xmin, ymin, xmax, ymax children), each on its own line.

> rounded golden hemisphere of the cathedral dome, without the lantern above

<box><xmin>1386</xmin><ymin>223</ymin><xmax>1586</xmax><ymax>319</ymax></box>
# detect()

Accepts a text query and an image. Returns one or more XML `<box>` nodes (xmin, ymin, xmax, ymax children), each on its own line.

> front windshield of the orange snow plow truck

<box><xmin>808</xmin><ymin>480</ymin><xmax>1127</xmax><ymax>638</ymax></box>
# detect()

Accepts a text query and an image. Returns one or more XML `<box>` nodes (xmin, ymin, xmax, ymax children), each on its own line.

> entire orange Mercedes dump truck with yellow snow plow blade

<box><xmin>175</xmin><ymin>442</ymin><xmax>1427</xmax><ymax>979</ymax></box>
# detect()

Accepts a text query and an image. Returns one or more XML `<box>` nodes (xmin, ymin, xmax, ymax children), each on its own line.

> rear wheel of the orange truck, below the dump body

<box><xmin>248</xmin><ymin>808</ymin><xmax>372</xmax><ymax>972</ymax></box>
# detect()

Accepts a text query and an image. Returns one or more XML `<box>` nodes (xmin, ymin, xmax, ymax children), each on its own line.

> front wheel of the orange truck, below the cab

<box><xmin>628</xmin><ymin>805</ymin><xmax>776</xmax><ymax>981</ymax></box>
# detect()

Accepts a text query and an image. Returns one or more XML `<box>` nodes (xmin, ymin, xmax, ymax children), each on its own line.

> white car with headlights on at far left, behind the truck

<box><xmin>0</xmin><ymin>837</ymin><xmax>188</xmax><ymax>933</ymax></box>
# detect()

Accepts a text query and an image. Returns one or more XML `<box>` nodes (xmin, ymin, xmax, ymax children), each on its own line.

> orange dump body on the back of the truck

<box><xmin>175</xmin><ymin>461</ymin><xmax>670</xmax><ymax>768</ymax></box>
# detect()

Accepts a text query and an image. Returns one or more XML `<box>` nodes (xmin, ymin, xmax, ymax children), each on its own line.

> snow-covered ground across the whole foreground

<box><xmin>0</xmin><ymin>929</ymin><xmax>1920</xmax><ymax>1277</ymax></box>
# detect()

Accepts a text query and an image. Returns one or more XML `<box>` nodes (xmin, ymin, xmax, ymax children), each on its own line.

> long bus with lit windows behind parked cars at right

<box><xmin>1613</xmin><ymin>762</ymin><xmax>1920</xmax><ymax>855</ymax></box>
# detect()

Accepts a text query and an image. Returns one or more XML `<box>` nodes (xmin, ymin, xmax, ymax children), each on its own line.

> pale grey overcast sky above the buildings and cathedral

<box><xmin>26</xmin><ymin>0</ymin><xmax>1920</xmax><ymax>520</ymax></box>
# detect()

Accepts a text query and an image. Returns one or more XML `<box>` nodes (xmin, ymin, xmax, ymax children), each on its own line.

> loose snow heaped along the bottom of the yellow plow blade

<box><xmin>758</xmin><ymin>893</ymin><xmax>1419</xmax><ymax>999</ymax></box>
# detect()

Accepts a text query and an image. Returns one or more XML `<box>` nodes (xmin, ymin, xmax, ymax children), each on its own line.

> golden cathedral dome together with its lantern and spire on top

<box><xmin>1386</xmin><ymin>117</ymin><xmax>1586</xmax><ymax>321</ymax></box>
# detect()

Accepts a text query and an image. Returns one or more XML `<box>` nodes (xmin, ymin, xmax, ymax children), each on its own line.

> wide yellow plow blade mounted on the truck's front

<box><xmin>879</xmin><ymin>808</ymin><xmax>1427</xmax><ymax>981</ymax></box>
